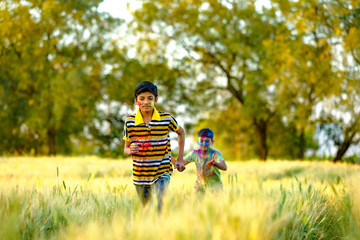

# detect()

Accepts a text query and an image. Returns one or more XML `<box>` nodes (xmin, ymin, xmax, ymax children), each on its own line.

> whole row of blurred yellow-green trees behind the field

<box><xmin>0</xmin><ymin>0</ymin><xmax>360</xmax><ymax>161</ymax></box>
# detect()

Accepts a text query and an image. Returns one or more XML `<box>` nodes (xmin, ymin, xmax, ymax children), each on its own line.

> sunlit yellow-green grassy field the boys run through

<box><xmin>0</xmin><ymin>157</ymin><xmax>360</xmax><ymax>239</ymax></box>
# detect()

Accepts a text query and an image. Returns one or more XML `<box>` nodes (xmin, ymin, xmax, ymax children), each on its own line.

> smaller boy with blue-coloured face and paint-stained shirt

<box><xmin>184</xmin><ymin>128</ymin><xmax>227</xmax><ymax>192</ymax></box>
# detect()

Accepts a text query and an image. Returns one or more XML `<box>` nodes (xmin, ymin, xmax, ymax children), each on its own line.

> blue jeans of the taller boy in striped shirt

<box><xmin>135</xmin><ymin>178</ymin><xmax>170</xmax><ymax>210</ymax></box>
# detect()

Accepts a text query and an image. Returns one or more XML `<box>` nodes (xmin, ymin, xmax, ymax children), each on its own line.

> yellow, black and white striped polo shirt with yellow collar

<box><xmin>124</xmin><ymin>108</ymin><xmax>179</xmax><ymax>185</ymax></box>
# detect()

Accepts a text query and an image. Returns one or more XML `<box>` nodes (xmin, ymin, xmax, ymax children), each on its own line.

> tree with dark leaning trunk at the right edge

<box><xmin>321</xmin><ymin>0</ymin><xmax>360</xmax><ymax>162</ymax></box>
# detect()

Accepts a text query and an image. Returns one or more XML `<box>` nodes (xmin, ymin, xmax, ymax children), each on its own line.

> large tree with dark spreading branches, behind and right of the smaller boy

<box><xmin>134</xmin><ymin>1</ymin><xmax>306</xmax><ymax>160</ymax></box>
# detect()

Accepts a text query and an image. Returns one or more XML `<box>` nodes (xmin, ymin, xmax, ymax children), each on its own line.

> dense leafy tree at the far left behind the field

<box><xmin>0</xmin><ymin>0</ymin><xmax>120</xmax><ymax>155</ymax></box>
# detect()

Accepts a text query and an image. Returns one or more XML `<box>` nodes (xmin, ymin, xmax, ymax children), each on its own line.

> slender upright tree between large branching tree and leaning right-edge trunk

<box><xmin>273</xmin><ymin>0</ymin><xmax>343</xmax><ymax>159</ymax></box>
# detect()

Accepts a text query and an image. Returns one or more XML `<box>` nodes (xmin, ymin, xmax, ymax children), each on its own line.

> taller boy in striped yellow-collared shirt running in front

<box><xmin>124</xmin><ymin>81</ymin><xmax>185</xmax><ymax>209</ymax></box>
